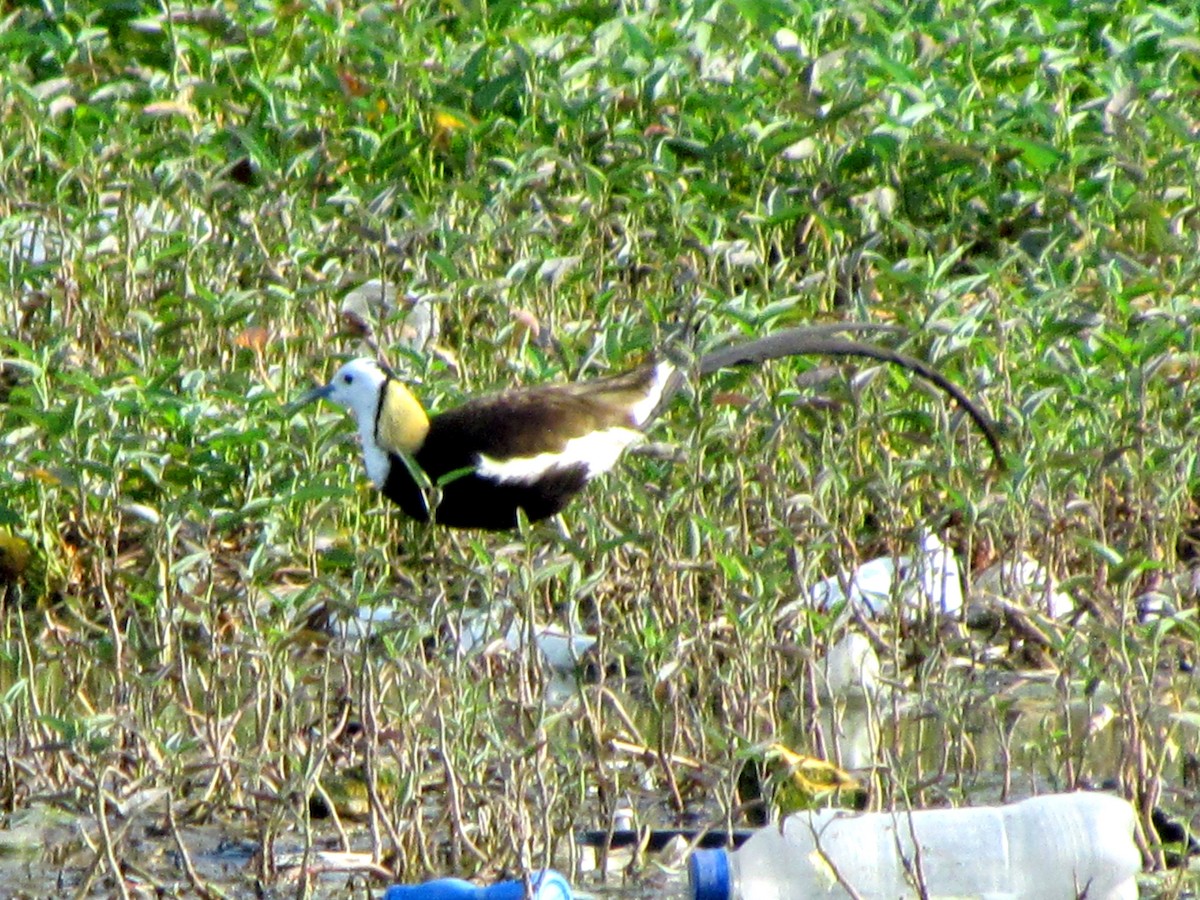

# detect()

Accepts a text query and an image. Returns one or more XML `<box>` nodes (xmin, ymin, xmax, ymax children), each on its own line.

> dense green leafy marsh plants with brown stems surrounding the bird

<box><xmin>0</xmin><ymin>0</ymin><xmax>1200</xmax><ymax>896</ymax></box>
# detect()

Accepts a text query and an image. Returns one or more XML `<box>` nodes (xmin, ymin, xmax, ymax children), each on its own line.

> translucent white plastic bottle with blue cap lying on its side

<box><xmin>688</xmin><ymin>792</ymin><xmax>1141</xmax><ymax>900</ymax></box>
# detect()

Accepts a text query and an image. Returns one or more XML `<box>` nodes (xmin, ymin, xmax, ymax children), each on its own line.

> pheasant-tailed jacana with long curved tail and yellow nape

<box><xmin>293</xmin><ymin>324</ymin><xmax>1003</xmax><ymax>530</ymax></box>
